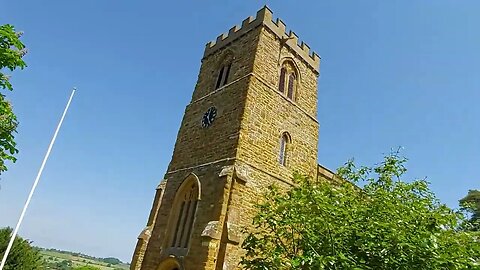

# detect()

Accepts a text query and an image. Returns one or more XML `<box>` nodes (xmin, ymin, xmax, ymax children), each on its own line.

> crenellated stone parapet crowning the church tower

<box><xmin>203</xmin><ymin>6</ymin><xmax>320</xmax><ymax>73</ymax></box>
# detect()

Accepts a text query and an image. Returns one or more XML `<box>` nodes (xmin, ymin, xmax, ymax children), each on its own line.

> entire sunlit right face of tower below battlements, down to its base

<box><xmin>212</xmin><ymin>24</ymin><xmax>319</xmax><ymax>270</ymax></box>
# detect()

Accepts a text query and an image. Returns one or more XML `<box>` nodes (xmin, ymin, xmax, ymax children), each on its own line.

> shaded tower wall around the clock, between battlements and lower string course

<box><xmin>168</xmin><ymin>29</ymin><xmax>259</xmax><ymax>171</ymax></box>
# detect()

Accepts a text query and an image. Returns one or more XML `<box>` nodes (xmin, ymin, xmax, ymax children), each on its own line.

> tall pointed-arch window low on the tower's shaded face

<box><xmin>171</xmin><ymin>177</ymin><xmax>199</xmax><ymax>248</ymax></box>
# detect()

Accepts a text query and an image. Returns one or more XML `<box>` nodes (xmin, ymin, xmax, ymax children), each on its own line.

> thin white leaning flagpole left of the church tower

<box><xmin>0</xmin><ymin>87</ymin><xmax>76</xmax><ymax>270</ymax></box>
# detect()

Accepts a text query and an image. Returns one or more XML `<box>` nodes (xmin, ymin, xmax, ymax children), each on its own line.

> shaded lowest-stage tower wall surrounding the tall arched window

<box><xmin>141</xmin><ymin>161</ymin><xmax>232</xmax><ymax>270</ymax></box>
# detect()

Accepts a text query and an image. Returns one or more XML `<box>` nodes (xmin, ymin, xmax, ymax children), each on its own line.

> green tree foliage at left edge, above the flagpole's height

<box><xmin>0</xmin><ymin>24</ymin><xmax>26</xmax><ymax>174</ymax></box>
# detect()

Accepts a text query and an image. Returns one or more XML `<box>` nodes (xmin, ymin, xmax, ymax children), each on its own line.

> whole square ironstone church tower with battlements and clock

<box><xmin>131</xmin><ymin>7</ymin><xmax>331</xmax><ymax>270</ymax></box>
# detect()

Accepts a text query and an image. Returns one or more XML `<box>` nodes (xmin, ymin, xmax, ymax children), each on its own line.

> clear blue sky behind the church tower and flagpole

<box><xmin>0</xmin><ymin>0</ymin><xmax>480</xmax><ymax>261</ymax></box>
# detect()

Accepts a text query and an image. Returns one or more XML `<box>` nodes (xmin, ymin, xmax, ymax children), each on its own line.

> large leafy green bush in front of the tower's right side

<box><xmin>241</xmin><ymin>153</ymin><xmax>480</xmax><ymax>270</ymax></box>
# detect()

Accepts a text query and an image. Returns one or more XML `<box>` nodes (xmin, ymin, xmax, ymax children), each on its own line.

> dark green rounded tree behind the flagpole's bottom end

<box><xmin>0</xmin><ymin>228</ymin><xmax>44</xmax><ymax>270</ymax></box>
